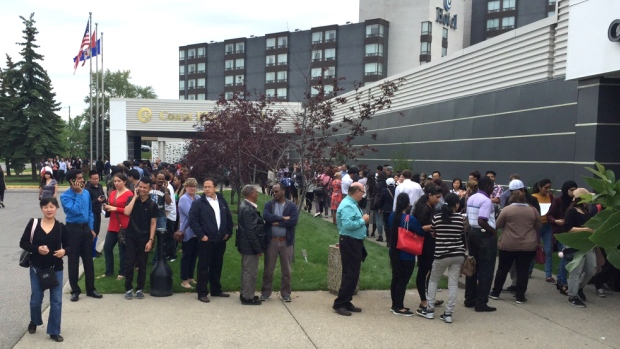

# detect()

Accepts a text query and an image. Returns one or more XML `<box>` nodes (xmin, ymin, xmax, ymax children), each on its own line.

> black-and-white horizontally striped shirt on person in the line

<box><xmin>431</xmin><ymin>212</ymin><xmax>465</xmax><ymax>259</ymax></box>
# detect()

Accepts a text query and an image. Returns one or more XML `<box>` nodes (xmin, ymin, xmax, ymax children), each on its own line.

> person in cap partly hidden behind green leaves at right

<box><xmin>564</xmin><ymin>188</ymin><xmax>596</xmax><ymax>308</ymax></box>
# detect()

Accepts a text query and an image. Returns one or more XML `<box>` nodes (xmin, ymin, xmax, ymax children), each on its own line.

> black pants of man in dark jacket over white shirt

<box><xmin>196</xmin><ymin>241</ymin><xmax>226</xmax><ymax>298</ymax></box>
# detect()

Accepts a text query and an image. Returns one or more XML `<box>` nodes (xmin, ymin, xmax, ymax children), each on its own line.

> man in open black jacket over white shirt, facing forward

<box><xmin>189</xmin><ymin>178</ymin><xmax>233</xmax><ymax>303</ymax></box>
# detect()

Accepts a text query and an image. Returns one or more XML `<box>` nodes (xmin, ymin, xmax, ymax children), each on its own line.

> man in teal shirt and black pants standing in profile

<box><xmin>332</xmin><ymin>182</ymin><xmax>369</xmax><ymax>316</ymax></box>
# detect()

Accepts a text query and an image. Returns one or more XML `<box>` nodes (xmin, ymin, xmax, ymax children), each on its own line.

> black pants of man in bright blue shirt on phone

<box><xmin>67</xmin><ymin>223</ymin><xmax>95</xmax><ymax>294</ymax></box>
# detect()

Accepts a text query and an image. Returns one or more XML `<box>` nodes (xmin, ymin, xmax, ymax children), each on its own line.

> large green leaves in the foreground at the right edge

<box><xmin>555</xmin><ymin>162</ymin><xmax>620</xmax><ymax>271</ymax></box>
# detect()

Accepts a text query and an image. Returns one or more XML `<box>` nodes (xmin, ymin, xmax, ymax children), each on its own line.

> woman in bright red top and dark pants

<box><xmin>100</xmin><ymin>173</ymin><xmax>133</xmax><ymax>280</ymax></box>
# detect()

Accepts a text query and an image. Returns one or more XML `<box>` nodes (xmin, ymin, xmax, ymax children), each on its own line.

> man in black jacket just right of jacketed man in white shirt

<box><xmin>236</xmin><ymin>185</ymin><xmax>265</xmax><ymax>305</ymax></box>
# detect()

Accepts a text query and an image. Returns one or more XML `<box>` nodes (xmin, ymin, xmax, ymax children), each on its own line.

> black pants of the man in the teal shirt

<box><xmin>334</xmin><ymin>235</ymin><xmax>364</xmax><ymax>308</ymax></box>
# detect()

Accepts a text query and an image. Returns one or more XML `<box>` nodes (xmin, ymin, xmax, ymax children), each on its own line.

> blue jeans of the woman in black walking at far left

<box><xmin>29</xmin><ymin>267</ymin><xmax>62</xmax><ymax>335</ymax></box>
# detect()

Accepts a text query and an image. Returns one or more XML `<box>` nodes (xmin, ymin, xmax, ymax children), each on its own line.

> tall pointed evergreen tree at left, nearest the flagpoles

<box><xmin>15</xmin><ymin>13</ymin><xmax>63</xmax><ymax>179</ymax></box>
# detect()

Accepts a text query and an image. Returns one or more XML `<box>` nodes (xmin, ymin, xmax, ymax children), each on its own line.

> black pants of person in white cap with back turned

<box><xmin>493</xmin><ymin>250</ymin><xmax>536</xmax><ymax>301</ymax></box>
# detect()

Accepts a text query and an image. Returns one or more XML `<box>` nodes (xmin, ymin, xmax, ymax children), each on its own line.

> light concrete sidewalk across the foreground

<box><xmin>15</xmin><ymin>270</ymin><xmax>620</xmax><ymax>348</ymax></box>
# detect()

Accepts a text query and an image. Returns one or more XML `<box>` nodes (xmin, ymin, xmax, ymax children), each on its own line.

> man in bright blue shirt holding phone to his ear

<box><xmin>60</xmin><ymin>170</ymin><xmax>103</xmax><ymax>302</ymax></box>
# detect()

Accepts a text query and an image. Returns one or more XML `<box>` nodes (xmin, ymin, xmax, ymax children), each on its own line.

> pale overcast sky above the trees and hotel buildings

<box><xmin>0</xmin><ymin>0</ymin><xmax>359</xmax><ymax>119</ymax></box>
